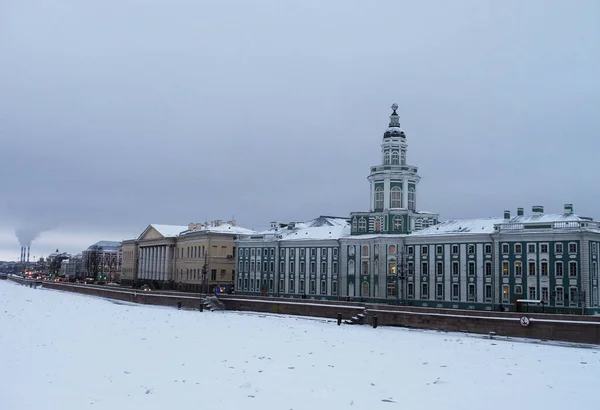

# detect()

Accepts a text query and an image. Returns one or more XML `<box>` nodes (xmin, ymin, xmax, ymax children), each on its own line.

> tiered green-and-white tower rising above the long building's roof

<box><xmin>350</xmin><ymin>104</ymin><xmax>438</xmax><ymax>235</ymax></box>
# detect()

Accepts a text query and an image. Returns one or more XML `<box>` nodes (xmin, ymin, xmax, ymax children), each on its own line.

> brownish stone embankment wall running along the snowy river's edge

<box><xmin>9</xmin><ymin>277</ymin><xmax>600</xmax><ymax>345</ymax></box>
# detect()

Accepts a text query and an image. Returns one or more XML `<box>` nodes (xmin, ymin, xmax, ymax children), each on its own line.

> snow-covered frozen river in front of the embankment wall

<box><xmin>0</xmin><ymin>281</ymin><xmax>600</xmax><ymax>410</ymax></box>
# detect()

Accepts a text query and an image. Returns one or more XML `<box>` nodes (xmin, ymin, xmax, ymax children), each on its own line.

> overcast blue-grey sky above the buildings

<box><xmin>0</xmin><ymin>0</ymin><xmax>600</xmax><ymax>260</ymax></box>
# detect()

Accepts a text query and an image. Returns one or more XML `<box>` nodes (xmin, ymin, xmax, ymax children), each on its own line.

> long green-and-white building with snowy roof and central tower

<box><xmin>236</xmin><ymin>104</ymin><xmax>600</xmax><ymax>314</ymax></box>
